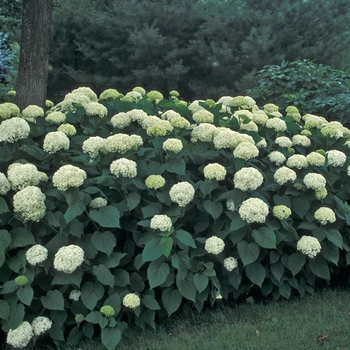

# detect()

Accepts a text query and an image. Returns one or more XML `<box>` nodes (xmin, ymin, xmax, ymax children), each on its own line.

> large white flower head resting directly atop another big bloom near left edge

<box><xmin>7</xmin><ymin>163</ymin><xmax>41</xmax><ymax>191</ymax></box>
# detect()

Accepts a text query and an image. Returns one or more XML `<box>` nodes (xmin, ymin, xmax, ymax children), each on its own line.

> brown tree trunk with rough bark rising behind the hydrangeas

<box><xmin>16</xmin><ymin>0</ymin><xmax>52</xmax><ymax>110</ymax></box>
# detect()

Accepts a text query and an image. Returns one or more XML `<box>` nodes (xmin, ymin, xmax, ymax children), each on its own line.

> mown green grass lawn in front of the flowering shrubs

<box><xmin>44</xmin><ymin>290</ymin><xmax>350</xmax><ymax>350</ymax></box>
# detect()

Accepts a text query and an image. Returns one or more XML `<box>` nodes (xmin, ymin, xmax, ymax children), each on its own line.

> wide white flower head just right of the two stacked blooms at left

<box><xmin>52</xmin><ymin>164</ymin><xmax>86</xmax><ymax>191</ymax></box>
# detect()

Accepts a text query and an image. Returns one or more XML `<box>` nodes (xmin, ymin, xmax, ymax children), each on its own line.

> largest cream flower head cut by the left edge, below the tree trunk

<box><xmin>0</xmin><ymin>117</ymin><xmax>30</xmax><ymax>143</ymax></box>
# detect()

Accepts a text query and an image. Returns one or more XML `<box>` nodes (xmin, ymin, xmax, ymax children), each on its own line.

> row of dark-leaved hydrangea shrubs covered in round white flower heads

<box><xmin>0</xmin><ymin>87</ymin><xmax>350</xmax><ymax>350</ymax></box>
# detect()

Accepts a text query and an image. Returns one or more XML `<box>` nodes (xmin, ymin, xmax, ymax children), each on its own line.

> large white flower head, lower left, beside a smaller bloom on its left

<box><xmin>53</xmin><ymin>244</ymin><xmax>84</xmax><ymax>274</ymax></box>
